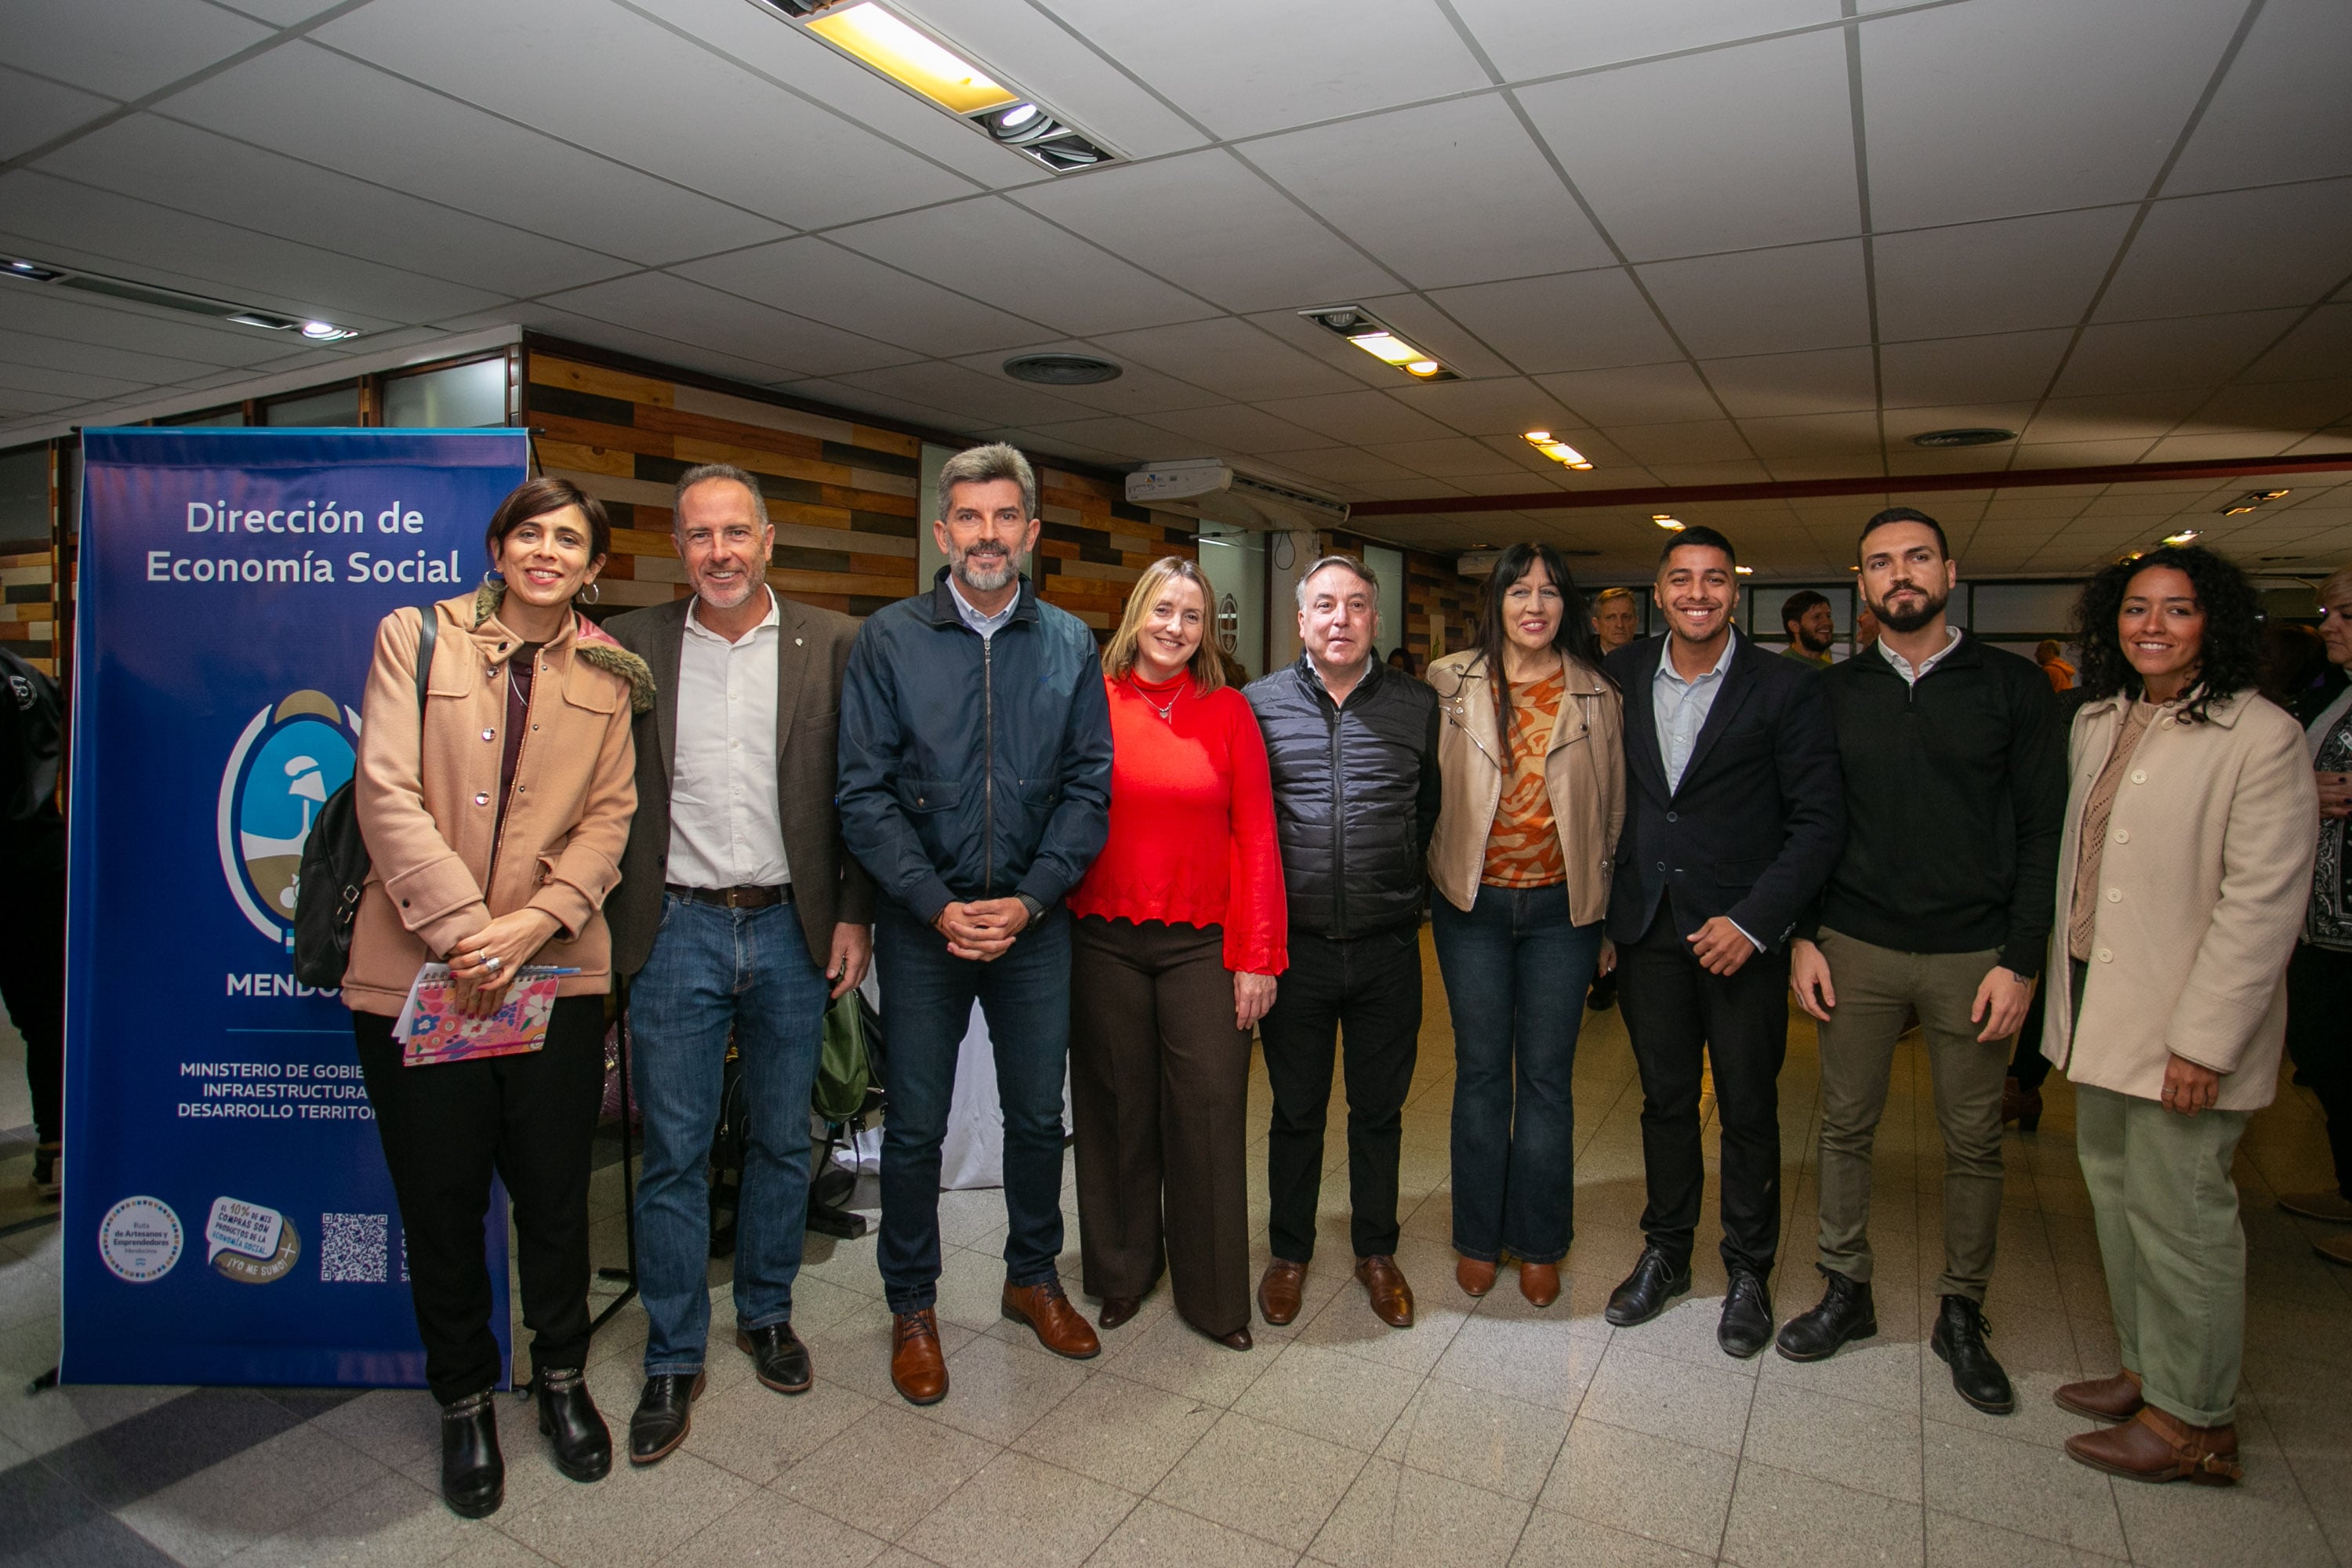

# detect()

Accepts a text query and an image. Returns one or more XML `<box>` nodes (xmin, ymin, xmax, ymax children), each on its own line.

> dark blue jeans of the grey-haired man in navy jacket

<box><xmin>875</xmin><ymin>898</ymin><xmax>1070</xmax><ymax>1312</ymax></box>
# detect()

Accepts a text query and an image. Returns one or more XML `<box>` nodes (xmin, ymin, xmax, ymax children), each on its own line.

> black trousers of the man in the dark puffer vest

<box><xmin>1258</xmin><ymin>921</ymin><xmax>1421</xmax><ymax>1262</ymax></box>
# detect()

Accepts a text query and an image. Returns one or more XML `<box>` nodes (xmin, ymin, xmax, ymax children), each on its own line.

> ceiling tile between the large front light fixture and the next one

<box><xmin>1014</xmin><ymin>151</ymin><xmax>1397</xmax><ymax>310</ymax></box>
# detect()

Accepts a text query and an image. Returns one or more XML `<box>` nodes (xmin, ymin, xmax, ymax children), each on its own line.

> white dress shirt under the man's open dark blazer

<box><xmin>666</xmin><ymin>586</ymin><xmax>793</xmax><ymax>888</ymax></box>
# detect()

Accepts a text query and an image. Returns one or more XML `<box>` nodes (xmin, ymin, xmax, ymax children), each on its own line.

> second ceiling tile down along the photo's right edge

<box><xmin>2098</xmin><ymin>179</ymin><xmax>2352</xmax><ymax>322</ymax></box>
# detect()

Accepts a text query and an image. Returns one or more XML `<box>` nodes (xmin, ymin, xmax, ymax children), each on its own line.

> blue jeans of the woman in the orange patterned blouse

<box><xmin>1430</xmin><ymin>884</ymin><xmax>1602</xmax><ymax>1262</ymax></box>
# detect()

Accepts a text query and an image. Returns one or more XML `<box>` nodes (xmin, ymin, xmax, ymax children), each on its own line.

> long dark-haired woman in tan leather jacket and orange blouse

<box><xmin>1428</xmin><ymin>546</ymin><xmax>1625</xmax><ymax>1307</ymax></box>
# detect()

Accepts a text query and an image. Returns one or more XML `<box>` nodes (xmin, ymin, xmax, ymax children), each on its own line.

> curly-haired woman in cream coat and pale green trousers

<box><xmin>2042</xmin><ymin>546</ymin><xmax>2319</xmax><ymax>1486</ymax></box>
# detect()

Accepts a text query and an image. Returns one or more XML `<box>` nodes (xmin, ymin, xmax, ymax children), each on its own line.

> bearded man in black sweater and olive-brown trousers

<box><xmin>1778</xmin><ymin>506</ymin><xmax>2067</xmax><ymax>1415</ymax></box>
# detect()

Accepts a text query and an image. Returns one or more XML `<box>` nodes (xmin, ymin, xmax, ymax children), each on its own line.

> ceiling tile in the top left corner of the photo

<box><xmin>0</xmin><ymin>0</ymin><xmax>270</xmax><ymax>99</ymax></box>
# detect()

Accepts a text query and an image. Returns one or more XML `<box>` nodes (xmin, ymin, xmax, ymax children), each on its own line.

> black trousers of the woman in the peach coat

<box><xmin>350</xmin><ymin>996</ymin><xmax>604</xmax><ymax>1403</ymax></box>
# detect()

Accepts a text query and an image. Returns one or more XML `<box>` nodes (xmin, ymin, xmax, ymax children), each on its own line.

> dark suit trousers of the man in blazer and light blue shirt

<box><xmin>1618</xmin><ymin>900</ymin><xmax>1788</xmax><ymax>1274</ymax></box>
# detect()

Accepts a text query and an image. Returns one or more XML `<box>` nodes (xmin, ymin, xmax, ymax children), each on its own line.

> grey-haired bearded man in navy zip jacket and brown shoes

<box><xmin>840</xmin><ymin>445</ymin><xmax>1110</xmax><ymax>1406</ymax></box>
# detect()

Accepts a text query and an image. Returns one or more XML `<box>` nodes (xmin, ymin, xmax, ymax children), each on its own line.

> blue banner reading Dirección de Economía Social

<box><xmin>59</xmin><ymin>428</ymin><xmax>529</xmax><ymax>1385</ymax></box>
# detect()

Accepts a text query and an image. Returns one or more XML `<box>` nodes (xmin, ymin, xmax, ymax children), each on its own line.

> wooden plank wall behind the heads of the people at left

<box><xmin>524</xmin><ymin>350</ymin><xmax>1197</xmax><ymax>635</ymax></box>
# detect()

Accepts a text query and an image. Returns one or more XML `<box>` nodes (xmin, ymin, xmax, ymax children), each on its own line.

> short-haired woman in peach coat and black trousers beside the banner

<box><xmin>343</xmin><ymin>480</ymin><xmax>652</xmax><ymax>1519</ymax></box>
